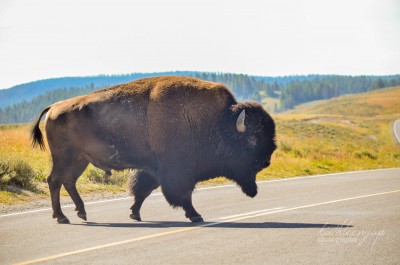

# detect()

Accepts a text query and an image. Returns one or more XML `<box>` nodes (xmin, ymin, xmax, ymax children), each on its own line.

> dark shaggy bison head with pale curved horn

<box><xmin>222</xmin><ymin>102</ymin><xmax>276</xmax><ymax>197</ymax></box>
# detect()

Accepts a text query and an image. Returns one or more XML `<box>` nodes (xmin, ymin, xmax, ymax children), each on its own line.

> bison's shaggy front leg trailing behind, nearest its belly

<box><xmin>129</xmin><ymin>170</ymin><xmax>160</xmax><ymax>221</ymax></box>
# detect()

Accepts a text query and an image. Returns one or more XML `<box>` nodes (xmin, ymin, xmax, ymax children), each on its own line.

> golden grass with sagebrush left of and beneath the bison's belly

<box><xmin>0</xmin><ymin>124</ymin><xmax>128</xmax><ymax>204</ymax></box>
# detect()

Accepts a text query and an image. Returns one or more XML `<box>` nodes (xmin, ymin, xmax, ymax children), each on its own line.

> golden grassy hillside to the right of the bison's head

<box><xmin>259</xmin><ymin>87</ymin><xmax>400</xmax><ymax>179</ymax></box>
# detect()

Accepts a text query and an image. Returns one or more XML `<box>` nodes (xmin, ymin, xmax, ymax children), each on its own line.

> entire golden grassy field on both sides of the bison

<box><xmin>0</xmin><ymin>87</ymin><xmax>400</xmax><ymax>204</ymax></box>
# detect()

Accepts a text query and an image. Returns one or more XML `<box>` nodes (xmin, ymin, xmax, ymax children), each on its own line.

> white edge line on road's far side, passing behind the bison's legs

<box><xmin>0</xmin><ymin>168</ymin><xmax>400</xmax><ymax>218</ymax></box>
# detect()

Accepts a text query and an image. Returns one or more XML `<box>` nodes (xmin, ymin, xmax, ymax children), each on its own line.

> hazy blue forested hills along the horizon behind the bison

<box><xmin>0</xmin><ymin>72</ymin><xmax>400</xmax><ymax>124</ymax></box>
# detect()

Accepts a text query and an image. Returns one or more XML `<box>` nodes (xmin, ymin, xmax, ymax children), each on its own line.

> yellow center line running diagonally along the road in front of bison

<box><xmin>16</xmin><ymin>190</ymin><xmax>400</xmax><ymax>265</ymax></box>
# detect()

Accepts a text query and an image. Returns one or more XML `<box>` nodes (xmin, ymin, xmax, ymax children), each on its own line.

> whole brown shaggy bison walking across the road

<box><xmin>32</xmin><ymin>76</ymin><xmax>276</xmax><ymax>223</ymax></box>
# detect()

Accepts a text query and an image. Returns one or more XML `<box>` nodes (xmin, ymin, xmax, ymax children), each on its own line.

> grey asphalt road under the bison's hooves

<box><xmin>0</xmin><ymin>169</ymin><xmax>400</xmax><ymax>264</ymax></box>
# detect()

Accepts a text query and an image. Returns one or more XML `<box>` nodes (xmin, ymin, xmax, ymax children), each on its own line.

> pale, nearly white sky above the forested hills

<box><xmin>0</xmin><ymin>0</ymin><xmax>400</xmax><ymax>88</ymax></box>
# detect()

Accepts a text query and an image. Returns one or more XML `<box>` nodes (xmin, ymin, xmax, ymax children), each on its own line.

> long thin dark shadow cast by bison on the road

<box><xmin>72</xmin><ymin>221</ymin><xmax>353</xmax><ymax>229</ymax></box>
